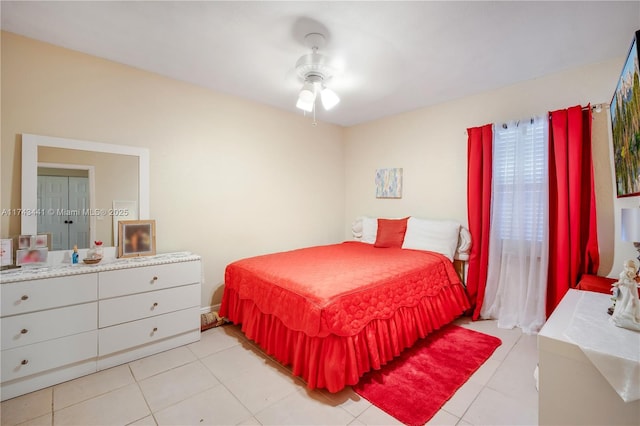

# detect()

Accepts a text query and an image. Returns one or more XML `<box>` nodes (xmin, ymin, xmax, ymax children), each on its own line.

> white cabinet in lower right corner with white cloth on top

<box><xmin>538</xmin><ymin>289</ymin><xmax>640</xmax><ymax>425</ymax></box>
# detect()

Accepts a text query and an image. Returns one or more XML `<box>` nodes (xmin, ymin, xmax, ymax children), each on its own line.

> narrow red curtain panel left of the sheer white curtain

<box><xmin>467</xmin><ymin>124</ymin><xmax>493</xmax><ymax>320</ymax></box>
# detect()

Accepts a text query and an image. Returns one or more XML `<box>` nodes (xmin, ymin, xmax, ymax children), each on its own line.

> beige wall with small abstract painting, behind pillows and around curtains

<box><xmin>345</xmin><ymin>58</ymin><xmax>638</xmax><ymax>275</ymax></box>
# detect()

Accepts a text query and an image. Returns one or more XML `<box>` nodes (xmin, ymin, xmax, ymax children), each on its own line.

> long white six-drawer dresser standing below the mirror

<box><xmin>0</xmin><ymin>253</ymin><xmax>202</xmax><ymax>401</ymax></box>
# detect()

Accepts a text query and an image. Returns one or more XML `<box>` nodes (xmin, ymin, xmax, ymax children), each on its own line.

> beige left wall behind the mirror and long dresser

<box><xmin>1</xmin><ymin>32</ymin><xmax>345</xmax><ymax>306</ymax></box>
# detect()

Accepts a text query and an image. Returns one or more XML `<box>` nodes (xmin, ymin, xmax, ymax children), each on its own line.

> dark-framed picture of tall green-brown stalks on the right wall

<box><xmin>609</xmin><ymin>30</ymin><xmax>640</xmax><ymax>197</ymax></box>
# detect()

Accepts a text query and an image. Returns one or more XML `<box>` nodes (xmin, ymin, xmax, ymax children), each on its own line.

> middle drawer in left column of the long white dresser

<box><xmin>0</xmin><ymin>302</ymin><xmax>98</xmax><ymax>350</ymax></box>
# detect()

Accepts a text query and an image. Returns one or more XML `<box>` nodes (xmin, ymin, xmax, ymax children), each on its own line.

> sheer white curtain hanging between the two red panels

<box><xmin>480</xmin><ymin>117</ymin><xmax>549</xmax><ymax>334</ymax></box>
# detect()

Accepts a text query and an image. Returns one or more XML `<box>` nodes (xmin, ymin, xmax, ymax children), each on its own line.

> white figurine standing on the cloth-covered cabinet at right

<box><xmin>611</xmin><ymin>260</ymin><xmax>640</xmax><ymax>331</ymax></box>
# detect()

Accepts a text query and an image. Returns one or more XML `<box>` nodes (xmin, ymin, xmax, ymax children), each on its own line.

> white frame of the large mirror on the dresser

<box><xmin>20</xmin><ymin>133</ymin><xmax>149</xmax><ymax>246</ymax></box>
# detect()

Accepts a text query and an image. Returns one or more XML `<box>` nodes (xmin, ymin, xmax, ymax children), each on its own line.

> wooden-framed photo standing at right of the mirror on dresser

<box><xmin>118</xmin><ymin>220</ymin><xmax>156</xmax><ymax>257</ymax></box>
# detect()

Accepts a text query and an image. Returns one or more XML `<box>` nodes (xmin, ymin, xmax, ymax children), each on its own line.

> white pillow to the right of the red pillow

<box><xmin>402</xmin><ymin>217</ymin><xmax>460</xmax><ymax>262</ymax></box>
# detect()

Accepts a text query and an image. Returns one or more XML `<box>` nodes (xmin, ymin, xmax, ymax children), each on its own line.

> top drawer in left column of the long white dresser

<box><xmin>0</xmin><ymin>273</ymin><xmax>98</xmax><ymax>317</ymax></box>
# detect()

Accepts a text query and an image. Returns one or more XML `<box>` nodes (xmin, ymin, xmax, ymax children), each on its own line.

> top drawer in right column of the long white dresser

<box><xmin>98</xmin><ymin>261</ymin><xmax>202</xmax><ymax>299</ymax></box>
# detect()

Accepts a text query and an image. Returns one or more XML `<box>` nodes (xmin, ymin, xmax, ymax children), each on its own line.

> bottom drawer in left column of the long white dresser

<box><xmin>1</xmin><ymin>330</ymin><xmax>97</xmax><ymax>382</ymax></box>
